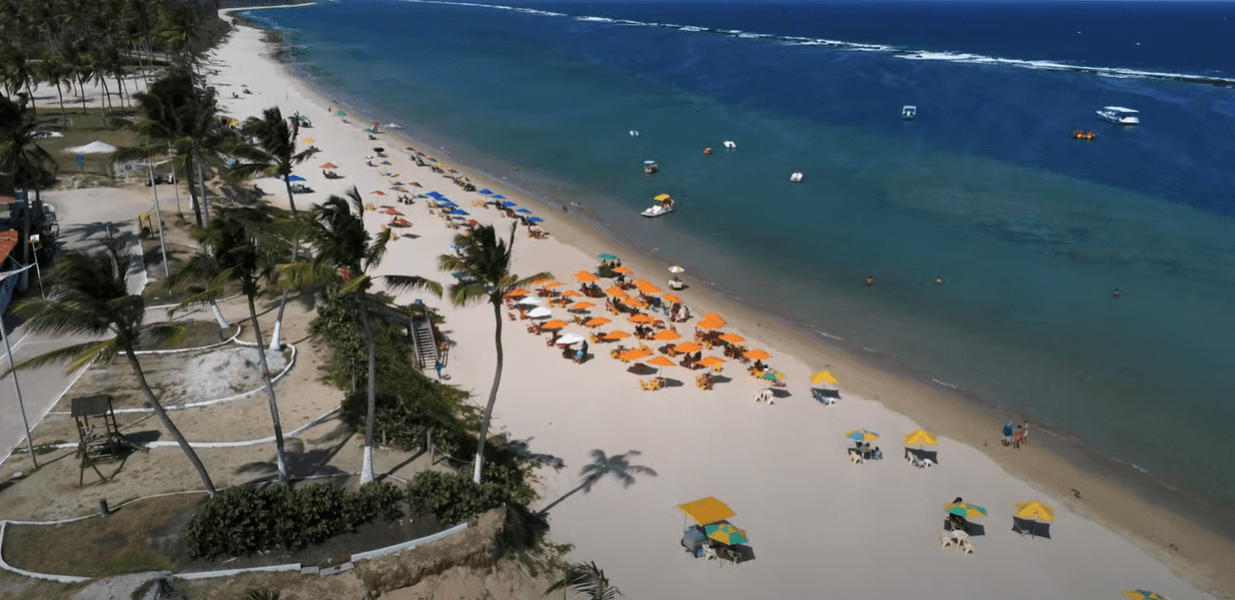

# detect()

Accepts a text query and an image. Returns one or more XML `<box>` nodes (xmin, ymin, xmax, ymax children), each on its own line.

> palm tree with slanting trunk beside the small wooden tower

<box><xmin>15</xmin><ymin>238</ymin><xmax>215</xmax><ymax>496</ymax></box>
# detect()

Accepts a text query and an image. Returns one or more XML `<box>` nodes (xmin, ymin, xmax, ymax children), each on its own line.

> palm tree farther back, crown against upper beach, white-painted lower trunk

<box><xmin>235</xmin><ymin>106</ymin><xmax>317</xmax><ymax>351</ymax></box>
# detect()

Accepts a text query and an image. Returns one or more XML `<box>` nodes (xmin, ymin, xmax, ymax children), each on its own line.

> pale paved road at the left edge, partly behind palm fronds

<box><xmin>0</xmin><ymin>186</ymin><xmax>159</xmax><ymax>464</ymax></box>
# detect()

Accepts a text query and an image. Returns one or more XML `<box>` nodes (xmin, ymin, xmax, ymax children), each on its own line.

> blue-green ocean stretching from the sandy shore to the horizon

<box><xmin>238</xmin><ymin>0</ymin><xmax>1235</xmax><ymax>514</ymax></box>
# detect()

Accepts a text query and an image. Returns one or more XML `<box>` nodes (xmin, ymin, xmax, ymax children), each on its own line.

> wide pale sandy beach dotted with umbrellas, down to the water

<box><xmin>209</xmin><ymin>8</ymin><xmax>1235</xmax><ymax>600</ymax></box>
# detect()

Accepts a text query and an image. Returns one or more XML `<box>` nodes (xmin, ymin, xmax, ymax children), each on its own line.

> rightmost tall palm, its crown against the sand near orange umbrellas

<box><xmin>437</xmin><ymin>223</ymin><xmax>553</xmax><ymax>484</ymax></box>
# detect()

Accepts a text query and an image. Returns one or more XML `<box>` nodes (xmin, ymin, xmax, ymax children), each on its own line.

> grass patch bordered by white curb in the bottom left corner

<box><xmin>4</xmin><ymin>494</ymin><xmax>205</xmax><ymax>577</ymax></box>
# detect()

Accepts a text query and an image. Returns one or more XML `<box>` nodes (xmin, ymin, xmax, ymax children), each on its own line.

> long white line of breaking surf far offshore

<box><xmin>404</xmin><ymin>0</ymin><xmax>1235</xmax><ymax>88</ymax></box>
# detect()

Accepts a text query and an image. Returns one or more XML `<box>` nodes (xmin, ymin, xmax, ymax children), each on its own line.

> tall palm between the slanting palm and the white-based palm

<box><xmin>180</xmin><ymin>204</ymin><xmax>288</xmax><ymax>485</ymax></box>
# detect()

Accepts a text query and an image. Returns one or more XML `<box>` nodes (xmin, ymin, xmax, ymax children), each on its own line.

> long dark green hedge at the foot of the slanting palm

<box><xmin>182</xmin><ymin>483</ymin><xmax>404</xmax><ymax>559</ymax></box>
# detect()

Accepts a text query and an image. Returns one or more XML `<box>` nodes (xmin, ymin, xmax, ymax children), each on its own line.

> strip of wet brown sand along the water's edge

<box><xmin>217</xmin><ymin>7</ymin><xmax>1235</xmax><ymax>590</ymax></box>
